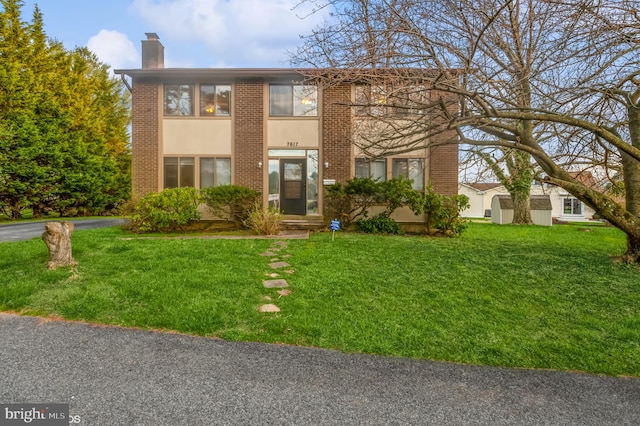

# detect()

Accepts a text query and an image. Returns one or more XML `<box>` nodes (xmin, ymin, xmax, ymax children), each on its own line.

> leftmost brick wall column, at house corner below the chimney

<box><xmin>131</xmin><ymin>83</ymin><xmax>160</xmax><ymax>200</ymax></box>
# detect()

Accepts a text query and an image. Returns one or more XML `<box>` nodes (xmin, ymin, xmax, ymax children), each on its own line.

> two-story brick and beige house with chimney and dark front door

<box><xmin>115</xmin><ymin>33</ymin><xmax>458</xmax><ymax>219</ymax></box>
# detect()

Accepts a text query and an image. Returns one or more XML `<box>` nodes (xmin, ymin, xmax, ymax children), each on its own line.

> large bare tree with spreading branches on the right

<box><xmin>292</xmin><ymin>0</ymin><xmax>640</xmax><ymax>263</ymax></box>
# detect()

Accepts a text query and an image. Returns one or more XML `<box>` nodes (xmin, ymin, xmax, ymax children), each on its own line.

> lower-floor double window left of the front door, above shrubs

<box><xmin>164</xmin><ymin>157</ymin><xmax>231</xmax><ymax>189</ymax></box>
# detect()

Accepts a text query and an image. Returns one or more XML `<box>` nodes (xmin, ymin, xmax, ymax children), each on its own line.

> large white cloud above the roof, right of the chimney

<box><xmin>130</xmin><ymin>0</ymin><xmax>324</xmax><ymax>67</ymax></box>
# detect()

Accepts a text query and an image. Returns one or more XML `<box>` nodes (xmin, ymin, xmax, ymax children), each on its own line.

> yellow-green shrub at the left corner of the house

<box><xmin>131</xmin><ymin>187</ymin><xmax>200</xmax><ymax>233</ymax></box>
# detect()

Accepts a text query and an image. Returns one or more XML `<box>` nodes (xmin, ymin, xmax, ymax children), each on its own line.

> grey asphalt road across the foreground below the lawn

<box><xmin>0</xmin><ymin>314</ymin><xmax>640</xmax><ymax>426</ymax></box>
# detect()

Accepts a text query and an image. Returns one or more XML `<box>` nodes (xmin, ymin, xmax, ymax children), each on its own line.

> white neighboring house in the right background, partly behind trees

<box><xmin>458</xmin><ymin>172</ymin><xmax>596</xmax><ymax>222</ymax></box>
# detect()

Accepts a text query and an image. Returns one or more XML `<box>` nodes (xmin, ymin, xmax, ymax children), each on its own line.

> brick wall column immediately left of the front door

<box><xmin>233</xmin><ymin>79</ymin><xmax>266</xmax><ymax>192</ymax></box>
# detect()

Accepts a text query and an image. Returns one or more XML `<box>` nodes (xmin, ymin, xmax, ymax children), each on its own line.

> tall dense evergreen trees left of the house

<box><xmin>0</xmin><ymin>0</ymin><xmax>130</xmax><ymax>218</ymax></box>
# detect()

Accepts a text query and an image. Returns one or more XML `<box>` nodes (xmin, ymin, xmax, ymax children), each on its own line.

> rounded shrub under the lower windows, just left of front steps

<box><xmin>200</xmin><ymin>185</ymin><xmax>260</xmax><ymax>225</ymax></box>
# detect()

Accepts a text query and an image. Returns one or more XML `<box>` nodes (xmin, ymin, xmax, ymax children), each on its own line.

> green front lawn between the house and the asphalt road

<box><xmin>0</xmin><ymin>224</ymin><xmax>640</xmax><ymax>376</ymax></box>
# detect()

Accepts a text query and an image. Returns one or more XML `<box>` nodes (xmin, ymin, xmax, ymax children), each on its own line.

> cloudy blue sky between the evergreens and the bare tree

<box><xmin>22</xmin><ymin>0</ymin><xmax>328</xmax><ymax>69</ymax></box>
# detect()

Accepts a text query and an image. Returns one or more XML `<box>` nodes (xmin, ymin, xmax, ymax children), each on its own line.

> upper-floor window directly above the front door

<box><xmin>269</xmin><ymin>85</ymin><xmax>318</xmax><ymax>117</ymax></box>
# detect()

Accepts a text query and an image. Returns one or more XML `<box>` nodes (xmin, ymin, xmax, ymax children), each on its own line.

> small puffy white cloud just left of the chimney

<box><xmin>87</xmin><ymin>30</ymin><xmax>141</xmax><ymax>69</ymax></box>
